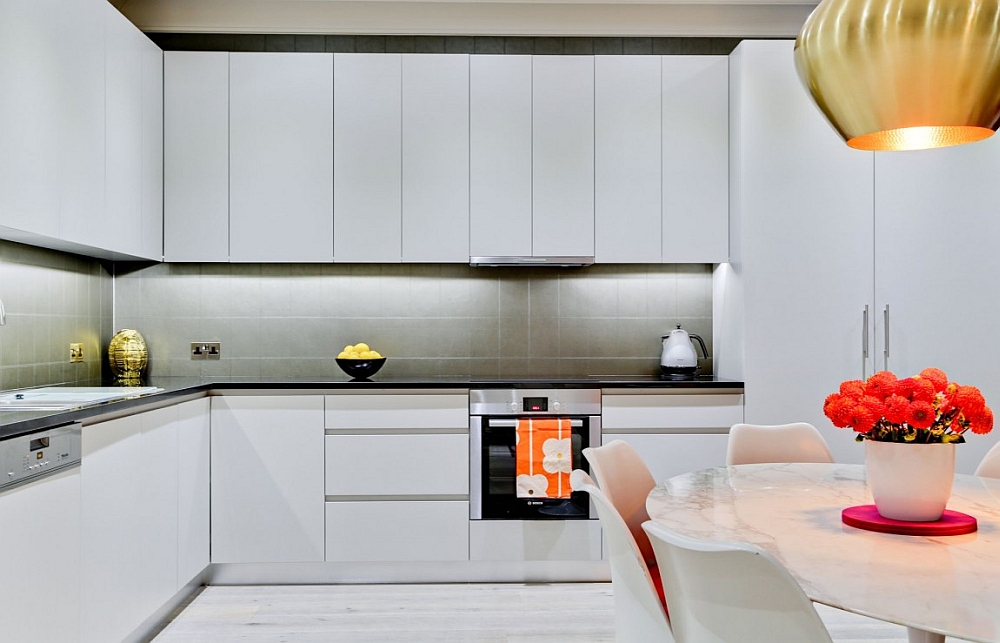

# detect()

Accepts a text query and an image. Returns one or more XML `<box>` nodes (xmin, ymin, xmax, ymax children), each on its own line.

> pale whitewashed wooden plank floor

<box><xmin>154</xmin><ymin>583</ymin><xmax>906</xmax><ymax>643</ymax></box>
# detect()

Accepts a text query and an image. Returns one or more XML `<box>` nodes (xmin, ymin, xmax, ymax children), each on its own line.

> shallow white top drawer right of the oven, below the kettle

<box><xmin>601</xmin><ymin>393</ymin><xmax>743</xmax><ymax>433</ymax></box>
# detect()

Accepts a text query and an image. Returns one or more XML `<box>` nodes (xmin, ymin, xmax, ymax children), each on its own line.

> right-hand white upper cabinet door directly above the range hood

<box><xmin>531</xmin><ymin>56</ymin><xmax>594</xmax><ymax>257</ymax></box>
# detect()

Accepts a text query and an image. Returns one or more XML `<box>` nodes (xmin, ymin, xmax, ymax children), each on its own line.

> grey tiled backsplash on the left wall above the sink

<box><xmin>0</xmin><ymin>241</ymin><xmax>112</xmax><ymax>389</ymax></box>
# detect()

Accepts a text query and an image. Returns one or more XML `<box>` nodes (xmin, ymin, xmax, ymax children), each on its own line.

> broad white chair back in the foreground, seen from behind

<box><xmin>643</xmin><ymin>521</ymin><xmax>832</xmax><ymax>643</ymax></box>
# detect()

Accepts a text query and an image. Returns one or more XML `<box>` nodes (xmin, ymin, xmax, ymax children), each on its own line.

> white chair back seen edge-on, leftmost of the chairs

<box><xmin>570</xmin><ymin>469</ymin><xmax>674</xmax><ymax>643</ymax></box>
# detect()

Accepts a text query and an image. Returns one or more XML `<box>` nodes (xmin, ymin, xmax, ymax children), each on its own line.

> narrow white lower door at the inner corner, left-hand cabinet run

<box><xmin>177</xmin><ymin>398</ymin><xmax>211</xmax><ymax>589</ymax></box>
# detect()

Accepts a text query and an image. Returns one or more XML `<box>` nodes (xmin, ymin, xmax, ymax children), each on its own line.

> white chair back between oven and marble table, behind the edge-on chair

<box><xmin>583</xmin><ymin>440</ymin><xmax>656</xmax><ymax>565</ymax></box>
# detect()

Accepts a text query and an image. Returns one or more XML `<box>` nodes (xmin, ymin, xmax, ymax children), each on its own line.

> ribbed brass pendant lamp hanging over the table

<box><xmin>795</xmin><ymin>0</ymin><xmax>1000</xmax><ymax>151</ymax></box>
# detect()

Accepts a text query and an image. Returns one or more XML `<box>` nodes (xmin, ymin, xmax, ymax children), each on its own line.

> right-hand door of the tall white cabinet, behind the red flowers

<box><xmin>875</xmin><ymin>137</ymin><xmax>1000</xmax><ymax>473</ymax></box>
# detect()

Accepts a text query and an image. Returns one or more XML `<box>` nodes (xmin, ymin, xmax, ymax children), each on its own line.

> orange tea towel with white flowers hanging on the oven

<box><xmin>515</xmin><ymin>418</ymin><xmax>573</xmax><ymax>498</ymax></box>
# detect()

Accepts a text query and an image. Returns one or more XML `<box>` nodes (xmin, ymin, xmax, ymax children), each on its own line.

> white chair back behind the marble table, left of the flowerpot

<box><xmin>726</xmin><ymin>422</ymin><xmax>833</xmax><ymax>465</ymax></box>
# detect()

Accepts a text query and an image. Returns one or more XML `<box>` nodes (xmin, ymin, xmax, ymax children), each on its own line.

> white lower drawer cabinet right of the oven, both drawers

<box><xmin>601</xmin><ymin>391</ymin><xmax>743</xmax><ymax>482</ymax></box>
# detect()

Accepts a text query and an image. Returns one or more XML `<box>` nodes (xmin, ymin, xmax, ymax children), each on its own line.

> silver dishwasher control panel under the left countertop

<box><xmin>0</xmin><ymin>424</ymin><xmax>80</xmax><ymax>489</ymax></box>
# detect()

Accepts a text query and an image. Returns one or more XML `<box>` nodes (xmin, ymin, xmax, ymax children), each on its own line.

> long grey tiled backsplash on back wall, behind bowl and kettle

<box><xmin>114</xmin><ymin>264</ymin><xmax>712</xmax><ymax>377</ymax></box>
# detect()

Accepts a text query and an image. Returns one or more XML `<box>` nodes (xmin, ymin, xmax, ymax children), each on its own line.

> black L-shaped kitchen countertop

<box><xmin>0</xmin><ymin>375</ymin><xmax>743</xmax><ymax>440</ymax></box>
